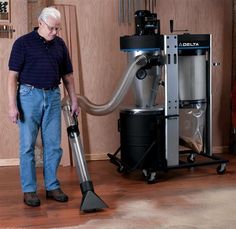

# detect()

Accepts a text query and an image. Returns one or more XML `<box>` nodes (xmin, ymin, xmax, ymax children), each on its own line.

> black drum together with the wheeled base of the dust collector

<box><xmin>107</xmin><ymin>108</ymin><xmax>229</xmax><ymax>183</ymax></box>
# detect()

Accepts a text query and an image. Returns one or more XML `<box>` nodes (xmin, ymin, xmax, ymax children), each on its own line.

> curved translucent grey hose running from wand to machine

<box><xmin>62</xmin><ymin>55</ymin><xmax>147</xmax><ymax>116</ymax></box>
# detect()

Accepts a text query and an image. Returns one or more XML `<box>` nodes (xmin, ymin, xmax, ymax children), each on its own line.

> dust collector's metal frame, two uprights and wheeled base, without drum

<box><xmin>108</xmin><ymin>34</ymin><xmax>229</xmax><ymax>183</ymax></box>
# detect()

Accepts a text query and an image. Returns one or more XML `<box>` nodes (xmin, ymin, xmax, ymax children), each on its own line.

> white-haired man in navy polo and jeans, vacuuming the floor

<box><xmin>8</xmin><ymin>7</ymin><xmax>79</xmax><ymax>206</ymax></box>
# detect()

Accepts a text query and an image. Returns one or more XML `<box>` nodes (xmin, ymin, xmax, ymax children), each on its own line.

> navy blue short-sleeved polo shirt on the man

<box><xmin>8</xmin><ymin>30</ymin><xmax>73</xmax><ymax>88</ymax></box>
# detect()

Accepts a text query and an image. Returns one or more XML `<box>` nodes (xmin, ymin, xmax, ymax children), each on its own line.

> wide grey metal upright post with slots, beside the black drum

<box><xmin>164</xmin><ymin>35</ymin><xmax>179</xmax><ymax>166</ymax></box>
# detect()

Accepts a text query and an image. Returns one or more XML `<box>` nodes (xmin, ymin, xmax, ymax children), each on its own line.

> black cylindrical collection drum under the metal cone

<box><xmin>119</xmin><ymin>109</ymin><xmax>166</xmax><ymax>170</ymax></box>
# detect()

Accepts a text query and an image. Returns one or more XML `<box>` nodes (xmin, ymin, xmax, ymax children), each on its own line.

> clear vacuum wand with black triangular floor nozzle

<box><xmin>62</xmin><ymin>101</ymin><xmax>108</xmax><ymax>212</ymax></box>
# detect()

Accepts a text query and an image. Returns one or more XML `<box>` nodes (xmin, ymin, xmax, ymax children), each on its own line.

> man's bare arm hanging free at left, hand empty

<box><xmin>8</xmin><ymin>70</ymin><xmax>20</xmax><ymax>123</ymax></box>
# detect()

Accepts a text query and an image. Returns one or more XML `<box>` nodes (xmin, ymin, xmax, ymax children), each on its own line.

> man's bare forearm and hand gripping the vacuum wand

<box><xmin>62</xmin><ymin>74</ymin><xmax>79</xmax><ymax>115</ymax></box>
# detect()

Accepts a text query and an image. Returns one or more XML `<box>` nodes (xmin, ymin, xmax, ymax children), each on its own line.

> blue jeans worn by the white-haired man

<box><xmin>17</xmin><ymin>85</ymin><xmax>62</xmax><ymax>192</ymax></box>
